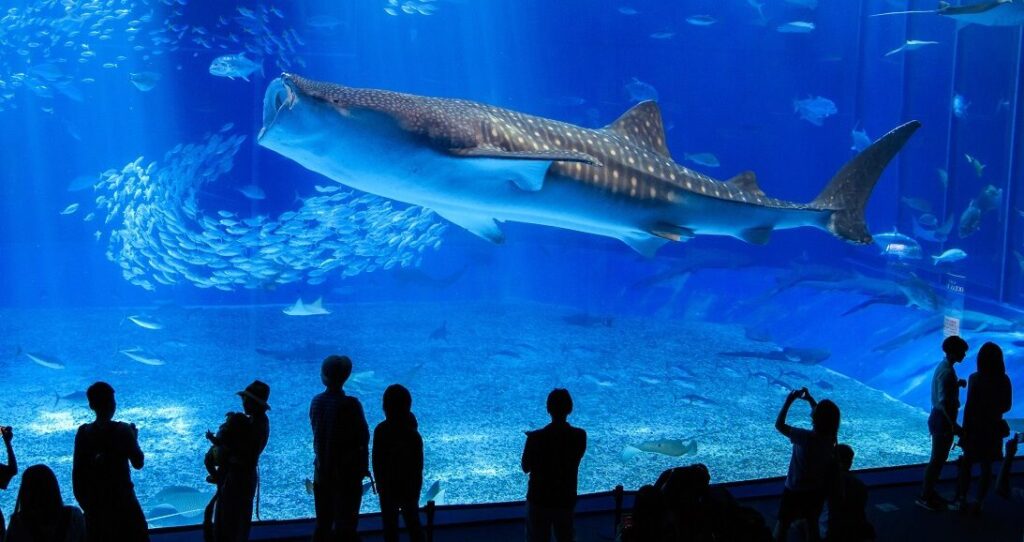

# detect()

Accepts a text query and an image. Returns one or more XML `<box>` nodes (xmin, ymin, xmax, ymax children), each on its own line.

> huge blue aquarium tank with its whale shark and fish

<box><xmin>0</xmin><ymin>0</ymin><xmax>1024</xmax><ymax>527</ymax></box>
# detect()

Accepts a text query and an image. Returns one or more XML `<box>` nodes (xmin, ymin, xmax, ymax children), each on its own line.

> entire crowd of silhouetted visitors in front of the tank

<box><xmin>0</xmin><ymin>336</ymin><xmax>1020</xmax><ymax>542</ymax></box>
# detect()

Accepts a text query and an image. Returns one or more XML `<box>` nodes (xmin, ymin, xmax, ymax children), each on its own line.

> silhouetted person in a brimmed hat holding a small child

<box><xmin>207</xmin><ymin>380</ymin><xmax>270</xmax><ymax>542</ymax></box>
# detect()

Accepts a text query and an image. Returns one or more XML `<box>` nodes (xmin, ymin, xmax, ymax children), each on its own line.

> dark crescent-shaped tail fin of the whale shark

<box><xmin>809</xmin><ymin>121</ymin><xmax>921</xmax><ymax>245</ymax></box>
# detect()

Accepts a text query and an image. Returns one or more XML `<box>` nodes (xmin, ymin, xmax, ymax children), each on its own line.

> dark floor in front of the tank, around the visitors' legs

<box><xmin>153</xmin><ymin>461</ymin><xmax>1024</xmax><ymax>542</ymax></box>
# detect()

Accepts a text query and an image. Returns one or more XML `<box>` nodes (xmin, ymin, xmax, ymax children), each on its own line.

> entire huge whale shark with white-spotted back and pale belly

<box><xmin>258</xmin><ymin>74</ymin><xmax>921</xmax><ymax>255</ymax></box>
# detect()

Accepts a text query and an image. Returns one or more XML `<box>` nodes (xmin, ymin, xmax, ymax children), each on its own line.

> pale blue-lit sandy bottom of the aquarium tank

<box><xmin>0</xmin><ymin>303</ymin><xmax>929</xmax><ymax>525</ymax></box>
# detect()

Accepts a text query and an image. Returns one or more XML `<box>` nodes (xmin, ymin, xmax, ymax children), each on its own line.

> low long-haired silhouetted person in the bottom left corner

<box><xmin>4</xmin><ymin>465</ymin><xmax>86</xmax><ymax>542</ymax></box>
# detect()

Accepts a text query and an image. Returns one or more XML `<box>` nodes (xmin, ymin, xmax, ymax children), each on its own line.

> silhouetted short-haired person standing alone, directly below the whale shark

<box><xmin>522</xmin><ymin>388</ymin><xmax>587</xmax><ymax>542</ymax></box>
